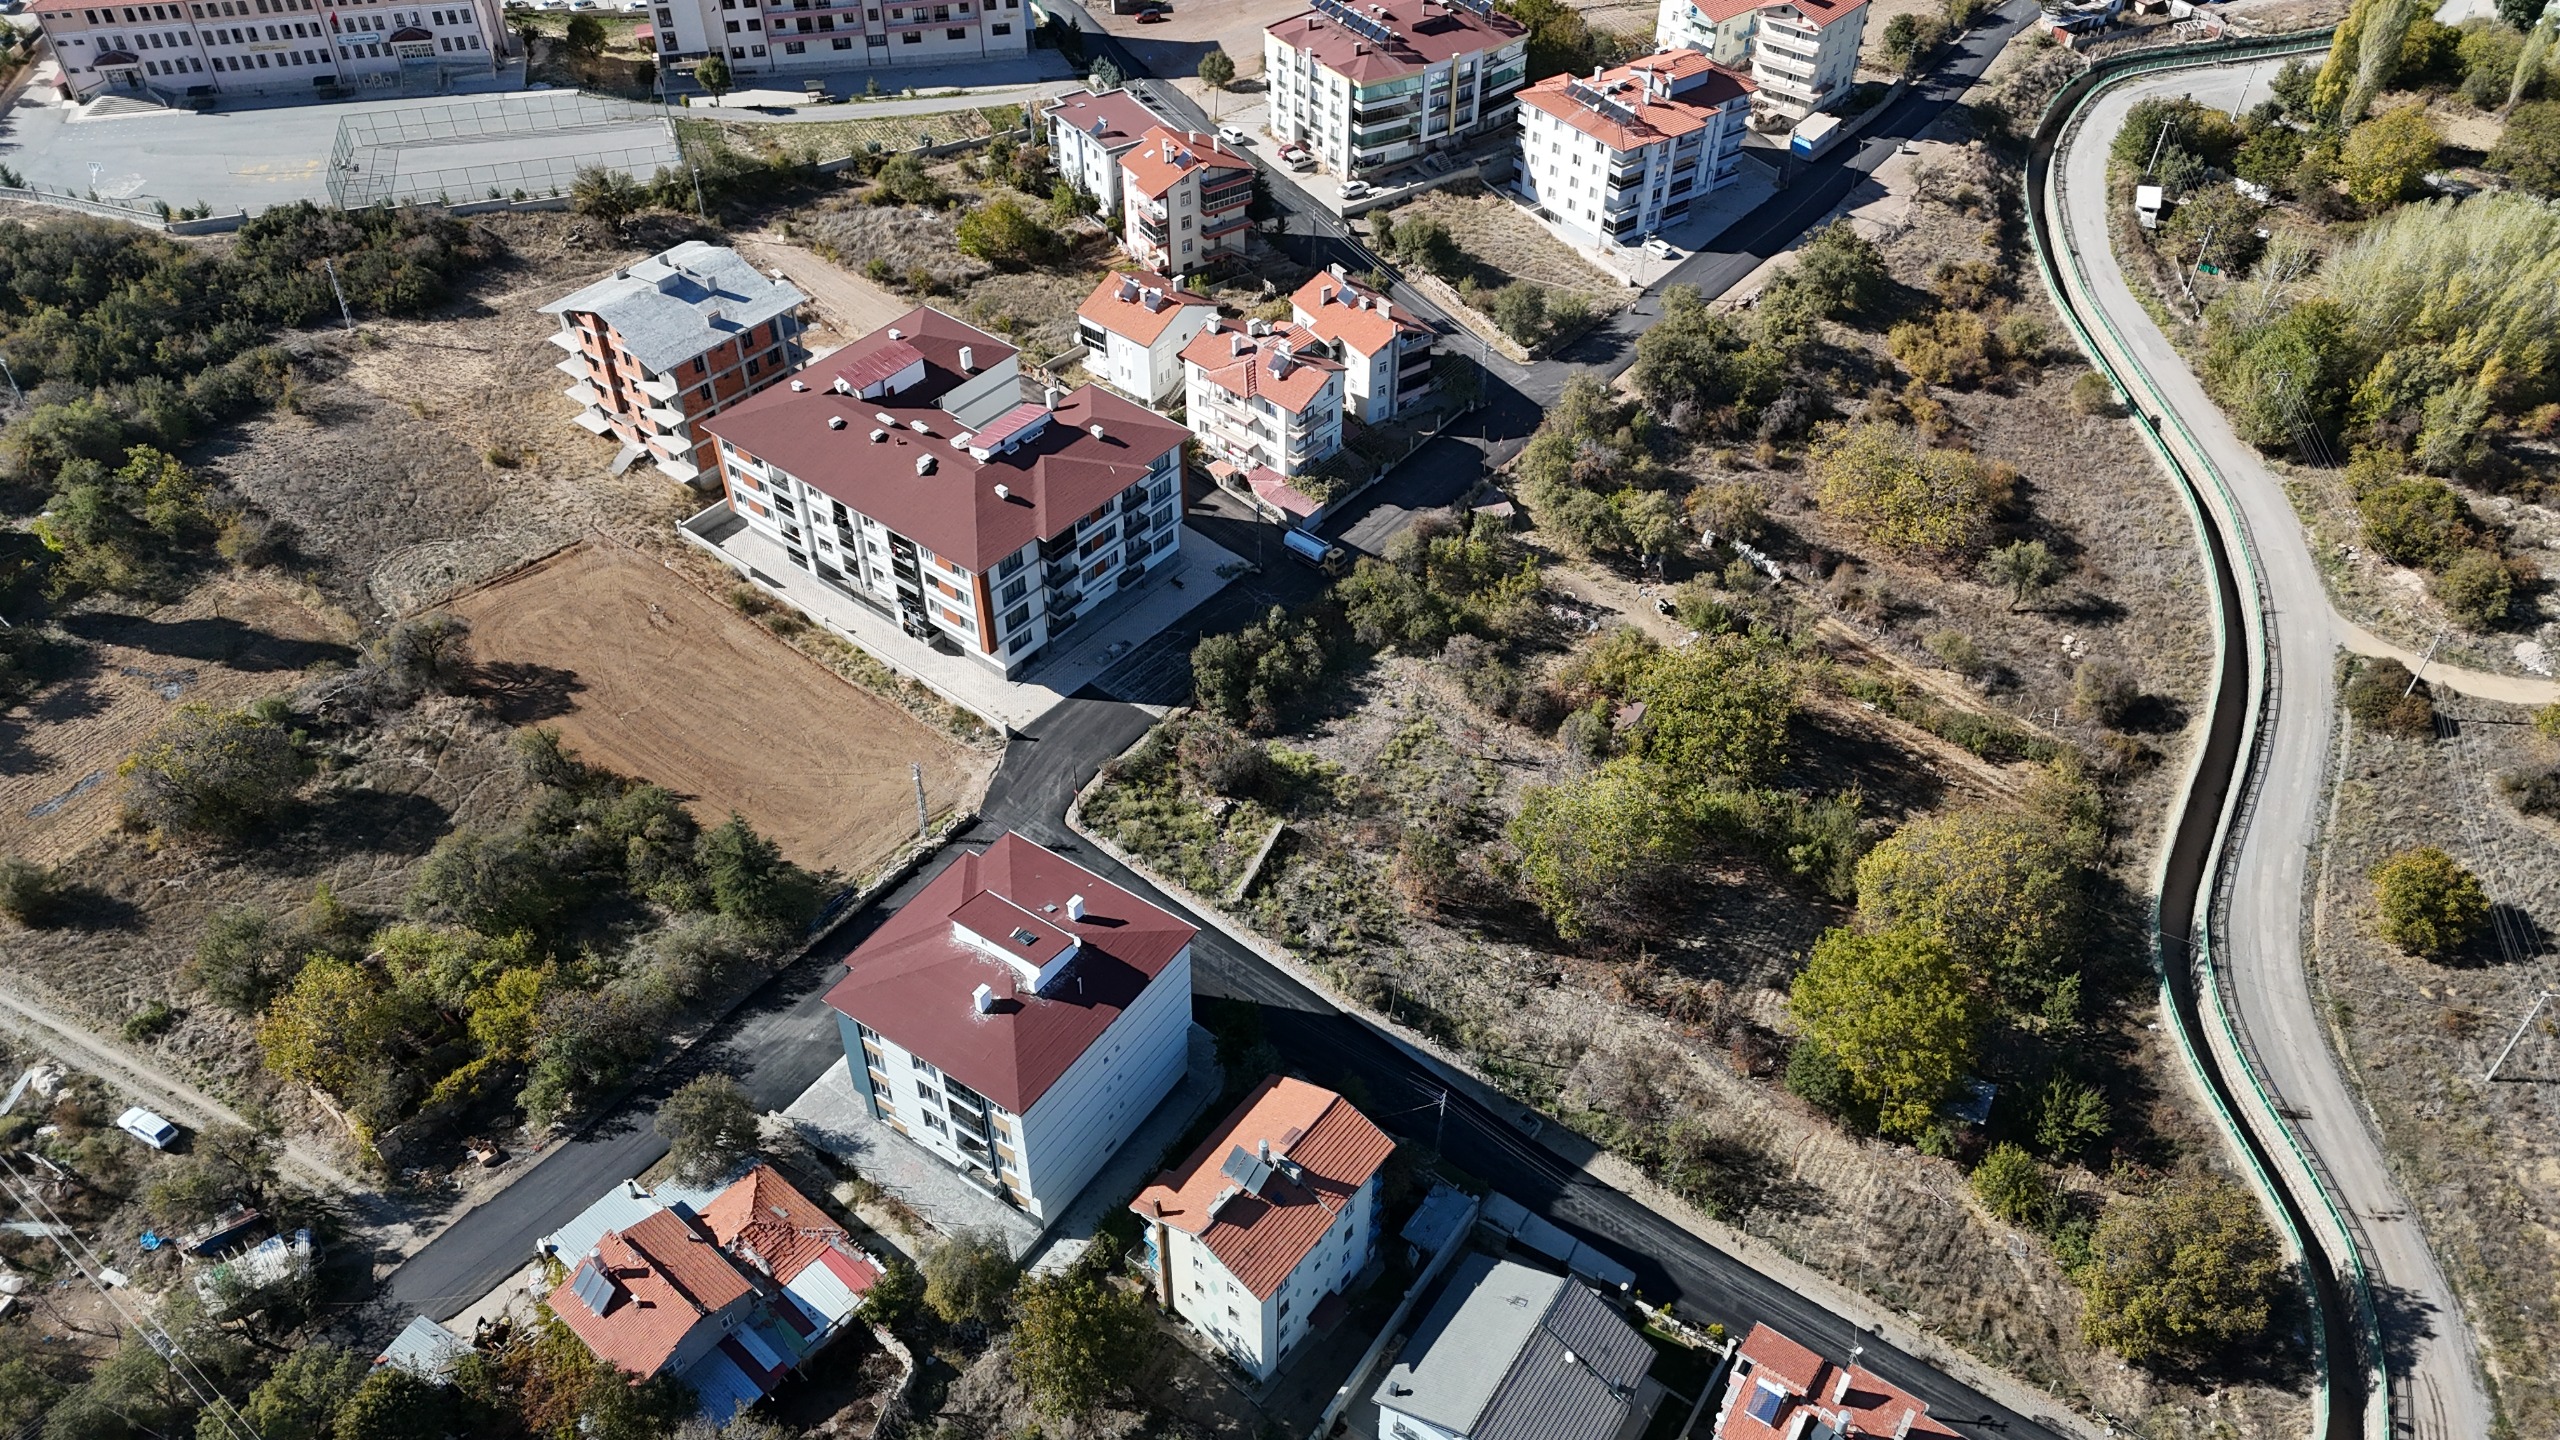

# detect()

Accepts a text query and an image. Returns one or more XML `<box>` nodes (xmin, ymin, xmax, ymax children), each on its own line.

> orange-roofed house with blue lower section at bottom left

<box><xmin>548</xmin><ymin>1166</ymin><xmax>881</xmax><ymax>1425</ymax></box>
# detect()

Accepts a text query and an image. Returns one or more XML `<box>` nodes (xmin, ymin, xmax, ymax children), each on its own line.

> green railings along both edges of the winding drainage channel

<box><xmin>2022</xmin><ymin>31</ymin><xmax>2391</xmax><ymax>1435</ymax></box>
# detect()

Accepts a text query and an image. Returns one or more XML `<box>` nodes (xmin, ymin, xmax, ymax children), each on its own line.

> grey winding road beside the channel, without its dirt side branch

<box><xmin>2053</xmin><ymin>64</ymin><xmax>2491</xmax><ymax>1440</ymax></box>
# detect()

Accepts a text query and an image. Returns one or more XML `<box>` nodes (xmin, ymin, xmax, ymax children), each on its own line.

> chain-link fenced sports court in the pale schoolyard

<box><xmin>328</xmin><ymin>90</ymin><xmax>684</xmax><ymax>210</ymax></box>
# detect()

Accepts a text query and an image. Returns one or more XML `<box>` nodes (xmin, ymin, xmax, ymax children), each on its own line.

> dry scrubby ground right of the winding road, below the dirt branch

<box><xmin>2312</xmin><ymin>697</ymin><xmax>2560</xmax><ymax>1440</ymax></box>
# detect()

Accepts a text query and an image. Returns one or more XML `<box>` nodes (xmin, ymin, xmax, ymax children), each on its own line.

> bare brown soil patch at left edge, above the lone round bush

<box><xmin>0</xmin><ymin>571</ymin><xmax>356</xmax><ymax>863</ymax></box>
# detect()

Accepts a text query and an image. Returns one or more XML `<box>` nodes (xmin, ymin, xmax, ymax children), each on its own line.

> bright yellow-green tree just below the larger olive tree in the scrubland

<box><xmin>1787</xmin><ymin>925</ymin><xmax>1979</xmax><ymax>1138</ymax></box>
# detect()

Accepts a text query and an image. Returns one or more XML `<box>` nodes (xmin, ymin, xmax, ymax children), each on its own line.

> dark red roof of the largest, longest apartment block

<box><xmin>701</xmin><ymin>307</ymin><xmax>1190</xmax><ymax>571</ymax></box>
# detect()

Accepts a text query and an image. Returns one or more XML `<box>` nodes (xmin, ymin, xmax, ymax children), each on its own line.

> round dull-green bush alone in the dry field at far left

<box><xmin>115</xmin><ymin>702</ymin><xmax>310</xmax><ymax>840</ymax></box>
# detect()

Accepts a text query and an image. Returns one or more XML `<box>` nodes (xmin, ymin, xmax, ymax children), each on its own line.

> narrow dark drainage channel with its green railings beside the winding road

<box><xmin>2025</xmin><ymin>31</ymin><xmax>2394</xmax><ymax>1440</ymax></box>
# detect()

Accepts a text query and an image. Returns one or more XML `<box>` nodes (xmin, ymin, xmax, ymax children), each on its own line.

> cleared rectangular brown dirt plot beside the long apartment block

<box><xmin>453</xmin><ymin>541</ymin><xmax>993</xmax><ymax>874</ymax></box>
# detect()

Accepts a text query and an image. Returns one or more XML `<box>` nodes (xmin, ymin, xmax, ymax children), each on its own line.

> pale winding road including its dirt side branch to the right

<box><xmin>2043</xmin><ymin>47</ymin><xmax>2560</xmax><ymax>1440</ymax></box>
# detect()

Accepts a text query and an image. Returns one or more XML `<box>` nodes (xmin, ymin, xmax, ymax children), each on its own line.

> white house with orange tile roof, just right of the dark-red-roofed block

<box><xmin>1129</xmin><ymin>1076</ymin><xmax>1395</xmax><ymax>1381</ymax></box>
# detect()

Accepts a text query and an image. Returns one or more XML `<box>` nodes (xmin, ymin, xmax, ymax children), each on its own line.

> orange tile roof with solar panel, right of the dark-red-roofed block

<box><xmin>1129</xmin><ymin>1076</ymin><xmax>1395</xmax><ymax>1299</ymax></box>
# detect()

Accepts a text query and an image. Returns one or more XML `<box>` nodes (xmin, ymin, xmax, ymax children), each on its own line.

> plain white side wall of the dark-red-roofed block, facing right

<box><xmin>1021</xmin><ymin>945</ymin><xmax>1190</xmax><ymax>1220</ymax></box>
